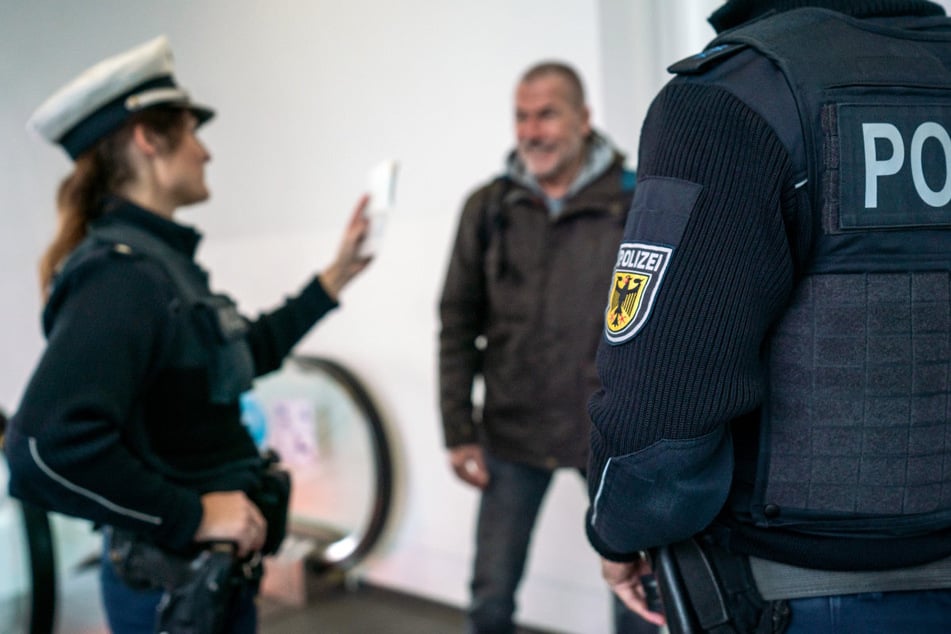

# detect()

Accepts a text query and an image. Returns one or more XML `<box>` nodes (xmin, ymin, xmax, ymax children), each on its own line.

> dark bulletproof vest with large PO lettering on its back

<box><xmin>684</xmin><ymin>9</ymin><xmax>951</xmax><ymax>537</ymax></box>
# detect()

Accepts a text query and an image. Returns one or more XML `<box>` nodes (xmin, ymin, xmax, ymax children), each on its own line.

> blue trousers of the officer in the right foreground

<box><xmin>786</xmin><ymin>590</ymin><xmax>951</xmax><ymax>634</ymax></box>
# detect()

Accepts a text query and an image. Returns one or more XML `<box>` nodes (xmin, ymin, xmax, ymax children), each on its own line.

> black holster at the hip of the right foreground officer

<box><xmin>650</xmin><ymin>535</ymin><xmax>789</xmax><ymax>634</ymax></box>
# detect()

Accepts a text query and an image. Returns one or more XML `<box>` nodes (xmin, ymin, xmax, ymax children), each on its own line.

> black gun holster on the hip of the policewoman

<box><xmin>109</xmin><ymin>530</ymin><xmax>262</xmax><ymax>634</ymax></box>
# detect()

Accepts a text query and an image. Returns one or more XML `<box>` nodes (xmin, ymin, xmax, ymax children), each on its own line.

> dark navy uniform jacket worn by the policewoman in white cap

<box><xmin>5</xmin><ymin>199</ymin><xmax>336</xmax><ymax>549</ymax></box>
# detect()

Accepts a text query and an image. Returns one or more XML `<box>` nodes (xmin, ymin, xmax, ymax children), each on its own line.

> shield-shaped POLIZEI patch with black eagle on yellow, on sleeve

<box><xmin>604</xmin><ymin>242</ymin><xmax>673</xmax><ymax>344</ymax></box>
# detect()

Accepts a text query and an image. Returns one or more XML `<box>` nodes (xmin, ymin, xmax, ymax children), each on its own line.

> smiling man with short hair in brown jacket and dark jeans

<box><xmin>439</xmin><ymin>62</ymin><xmax>654</xmax><ymax>634</ymax></box>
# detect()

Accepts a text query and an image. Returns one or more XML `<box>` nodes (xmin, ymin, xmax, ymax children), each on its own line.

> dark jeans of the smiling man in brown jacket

<box><xmin>468</xmin><ymin>452</ymin><xmax>657</xmax><ymax>634</ymax></box>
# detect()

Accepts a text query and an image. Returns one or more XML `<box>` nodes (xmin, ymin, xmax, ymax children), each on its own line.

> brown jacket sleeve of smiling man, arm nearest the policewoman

<box><xmin>439</xmin><ymin>188</ymin><xmax>488</xmax><ymax>447</ymax></box>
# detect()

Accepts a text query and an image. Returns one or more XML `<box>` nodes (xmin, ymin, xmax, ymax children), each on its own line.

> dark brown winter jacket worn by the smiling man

<box><xmin>439</xmin><ymin>146</ymin><xmax>634</xmax><ymax>469</ymax></box>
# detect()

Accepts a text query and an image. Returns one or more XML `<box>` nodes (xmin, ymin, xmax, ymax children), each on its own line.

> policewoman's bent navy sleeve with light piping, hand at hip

<box><xmin>5</xmin><ymin>252</ymin><xmax>202</xmax><ymax>548</ymax></box>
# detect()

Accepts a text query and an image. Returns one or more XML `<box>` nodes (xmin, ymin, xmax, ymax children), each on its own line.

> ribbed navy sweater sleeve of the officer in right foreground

<box><xmin>586</xmin><ymin>81</ymin><xmax>795</xmax><ymax>560</ymax></box>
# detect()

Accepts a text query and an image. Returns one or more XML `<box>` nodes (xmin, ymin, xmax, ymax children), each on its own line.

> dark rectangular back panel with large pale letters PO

<box><xmin>838</xmin><ymin>104</ymin><xmax>951</xmax><ymax>230</ymax></box>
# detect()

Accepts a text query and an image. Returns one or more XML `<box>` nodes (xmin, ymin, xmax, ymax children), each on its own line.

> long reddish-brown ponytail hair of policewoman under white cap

<box><xmin>39</xmin><ymin>107</ymin><xmax>186</xmax><ymax>297</ymax></box>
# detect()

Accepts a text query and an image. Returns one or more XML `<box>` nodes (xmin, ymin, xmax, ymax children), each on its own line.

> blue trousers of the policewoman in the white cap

<box><xmin>99</xmin><ymin>538</ymin><xmax>258</xmax><ymax>634</ymax></box>
